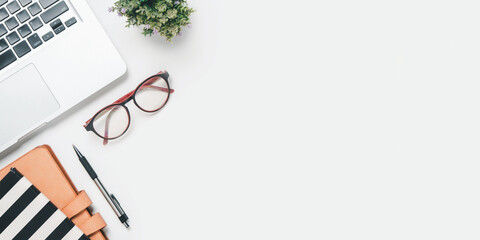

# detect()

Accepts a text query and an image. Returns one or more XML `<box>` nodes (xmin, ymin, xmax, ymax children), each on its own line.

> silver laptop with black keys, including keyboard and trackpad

<box><xmin>0</xmin><ymin>0</ymin><xmax>126</xmax><ymax>152</ymax></box>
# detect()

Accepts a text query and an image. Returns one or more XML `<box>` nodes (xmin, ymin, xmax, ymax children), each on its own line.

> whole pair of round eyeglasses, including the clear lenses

<box><xmin>84</xmin><ymin>71</ymin><xmax>174</xmax><ymax>145</ymax></box>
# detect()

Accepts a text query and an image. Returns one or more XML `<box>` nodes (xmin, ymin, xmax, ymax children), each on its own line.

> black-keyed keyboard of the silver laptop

<box><xmin>0</xmin><ymin>0</ymin><xmax>77</xmax><ymax>70</ymax></box>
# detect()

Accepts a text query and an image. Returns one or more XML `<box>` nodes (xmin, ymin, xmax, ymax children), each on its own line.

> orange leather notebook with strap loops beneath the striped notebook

<box><xmin>0</xmin><ymin>145</ymin><xmax>108</xmax><ymax>240</ymax></box>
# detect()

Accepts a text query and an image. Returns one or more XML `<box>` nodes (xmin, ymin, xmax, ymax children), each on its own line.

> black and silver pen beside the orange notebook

<box><xmin>73</xmin><ymin>145</ymin><xmax>130</xmax><ymax>228</ymax></box>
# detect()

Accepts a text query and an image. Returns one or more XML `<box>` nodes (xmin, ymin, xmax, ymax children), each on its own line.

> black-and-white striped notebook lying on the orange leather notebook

<box><xmin>0</xmin><ymin>168</ymin><xmax>88</xmax><ymax>240</ymax></box>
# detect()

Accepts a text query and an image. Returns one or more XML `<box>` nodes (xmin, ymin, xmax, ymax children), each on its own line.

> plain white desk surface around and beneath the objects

<box><xmin>0</xmin><ymin>0</ymin><xmax>480</xmax><ymax>240</ymax></box>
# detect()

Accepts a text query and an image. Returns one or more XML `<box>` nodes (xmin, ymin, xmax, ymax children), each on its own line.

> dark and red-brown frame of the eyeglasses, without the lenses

<box><xmin>83</xmin><ymin>71</ymin><xmax>175</xmax><ymax>145</ymax></box>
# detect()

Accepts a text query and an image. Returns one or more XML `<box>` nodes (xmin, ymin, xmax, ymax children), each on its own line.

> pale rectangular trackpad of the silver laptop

<box><xmin>0</xmin><ymin>64</ymin><xmax>60</xmax><ymax>146</ymax></box>
